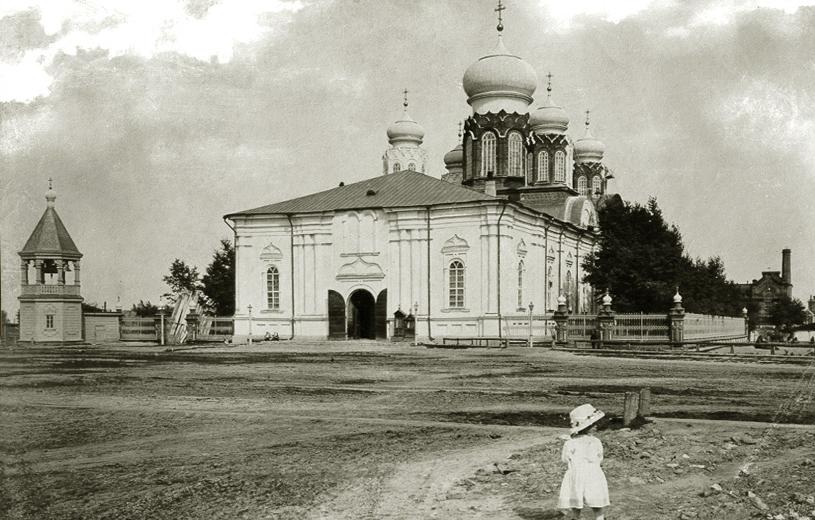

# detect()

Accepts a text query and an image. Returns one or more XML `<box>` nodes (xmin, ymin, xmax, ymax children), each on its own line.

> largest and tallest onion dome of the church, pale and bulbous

<box><xmin>462</xmin><ymin>34</ymin><xmax>538</xmax><ymax>112</ymax></box>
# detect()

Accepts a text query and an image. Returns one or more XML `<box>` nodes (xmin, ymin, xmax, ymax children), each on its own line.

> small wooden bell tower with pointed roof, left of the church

<box><xmin>18</xmin><ymin>181</ymin><xmax>82</xmax><ymax>343</ymax></box>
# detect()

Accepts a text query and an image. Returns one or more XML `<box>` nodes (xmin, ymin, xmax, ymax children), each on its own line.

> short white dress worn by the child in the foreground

<box><xmin>558</xmin><ymin>435</ymin><xmax>610</xmax><ymax>509</ymax></box>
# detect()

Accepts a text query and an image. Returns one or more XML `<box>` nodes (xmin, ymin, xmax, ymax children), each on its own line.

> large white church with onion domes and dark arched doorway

<box><xmin>224</xmin><ymin>11</ymin><xmax>618</xmax><ymax>340</ymax></box>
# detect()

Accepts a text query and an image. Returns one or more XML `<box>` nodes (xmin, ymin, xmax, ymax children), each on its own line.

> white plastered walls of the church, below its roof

<box><xmin>230</xmin><ymin>200</ymin><xmax>591</xmax><ymax>339</ymax></box>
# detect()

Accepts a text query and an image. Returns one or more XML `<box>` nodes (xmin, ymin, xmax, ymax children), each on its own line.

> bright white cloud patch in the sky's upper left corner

<box><xmin>0</xmin><ymin>0</ymin><xmax>304</xmax><ymax>103</ymax></box>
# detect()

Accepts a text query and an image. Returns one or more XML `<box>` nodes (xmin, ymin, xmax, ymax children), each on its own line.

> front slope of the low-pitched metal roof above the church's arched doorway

<box><xmin>226</xmin><ymin>171</ymin><xmax>499</xmax><ymax>218</ymax></box>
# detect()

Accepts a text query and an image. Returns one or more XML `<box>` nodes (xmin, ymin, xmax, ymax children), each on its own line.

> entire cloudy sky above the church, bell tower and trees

<box><xmin>0</xmin><ymin>0</ymin><xmax>815</xmax><ymax>313</ymax></box>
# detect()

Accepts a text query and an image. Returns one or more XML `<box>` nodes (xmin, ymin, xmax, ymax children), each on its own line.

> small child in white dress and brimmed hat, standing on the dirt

<box><xmin>558</xmin><ymin>404</ymin><xmax>609</xmax><ymax>520</ymax></box>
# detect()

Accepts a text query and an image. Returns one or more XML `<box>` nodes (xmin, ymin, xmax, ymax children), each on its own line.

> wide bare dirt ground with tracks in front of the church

<box><xmin>0</xmin><ymin>342</ymin><xmax>815</xmax><ymax>519</ymax></box>
